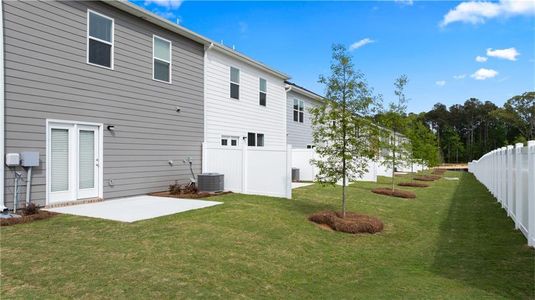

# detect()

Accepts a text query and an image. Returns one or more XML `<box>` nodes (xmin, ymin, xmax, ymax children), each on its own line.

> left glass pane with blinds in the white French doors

<box><xmin>50</xmin><ymin>129</ymin><xmax>69</xmax><ymax>192</ymax></box>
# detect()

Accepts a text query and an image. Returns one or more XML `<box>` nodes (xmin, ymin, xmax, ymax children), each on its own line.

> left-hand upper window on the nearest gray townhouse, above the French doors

<box><xmin>87</xmin><ymin>10</ymin><xmax>113</xmax><ymax>69</ymax></box>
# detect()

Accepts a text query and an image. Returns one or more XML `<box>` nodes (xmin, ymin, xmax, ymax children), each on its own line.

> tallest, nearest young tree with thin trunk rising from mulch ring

<box><xmin>311</xmin><ymin>45</ymin><xmax>378</xmax><ymax>217</ymax></box>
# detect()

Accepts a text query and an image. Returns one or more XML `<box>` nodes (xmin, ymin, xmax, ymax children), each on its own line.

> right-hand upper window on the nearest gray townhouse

<box><xmin>152</xmin><ymin>35</ymin><xmax>171</xmax><ymax>83</ymax></box>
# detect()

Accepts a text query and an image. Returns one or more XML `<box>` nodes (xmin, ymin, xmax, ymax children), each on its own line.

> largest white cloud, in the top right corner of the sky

<box><xmin>440</xmin><ymin>0</ymin><xmax>535</xmax><ymax>27</ymax></box>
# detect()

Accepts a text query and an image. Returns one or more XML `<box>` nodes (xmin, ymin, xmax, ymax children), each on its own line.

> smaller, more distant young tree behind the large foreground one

<box><xmin>378</xmin><ymin>75</ymin><xmax>410</xmax><ymax>191</ymax></box>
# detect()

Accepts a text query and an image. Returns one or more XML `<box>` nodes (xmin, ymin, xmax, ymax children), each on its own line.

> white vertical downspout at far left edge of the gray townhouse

<box><xmin>0</xmin><ymin>0</ymin><xmax>6</xmax><ymax>211</ymax></box>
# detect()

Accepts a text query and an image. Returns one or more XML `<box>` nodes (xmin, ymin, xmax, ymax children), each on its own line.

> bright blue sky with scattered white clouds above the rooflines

<box><xmin>133</xmin><ymin>0</ymin><xmax>535</xmax><ymax>112</ymax></box>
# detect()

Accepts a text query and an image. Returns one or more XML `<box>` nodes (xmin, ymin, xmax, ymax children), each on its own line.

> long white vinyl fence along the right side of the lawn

<box><xmin>468</xmin><ymin>141</ymin><xmax>535</xmax><ymax>247</ymax></box>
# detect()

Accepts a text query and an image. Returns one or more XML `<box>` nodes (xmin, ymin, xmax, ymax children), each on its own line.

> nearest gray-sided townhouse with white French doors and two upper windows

<box><xmin>1</xmin><ymin>1</ymin><xmax>210</xmax><ymax>208</ymax></box>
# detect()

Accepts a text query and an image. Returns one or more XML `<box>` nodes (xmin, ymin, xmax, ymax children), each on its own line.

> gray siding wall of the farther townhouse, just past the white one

<box><xmin>286</xmin><ymin>90</ymin><xmax>320</xmax><ymax>149</ymax></box>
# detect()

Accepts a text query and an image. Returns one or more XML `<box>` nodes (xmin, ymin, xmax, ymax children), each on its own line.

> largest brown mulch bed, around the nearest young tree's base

<box><xmin>308</xmin><ymin>211</ymin><xmax>384</xmax><ymax>233</ymax></box>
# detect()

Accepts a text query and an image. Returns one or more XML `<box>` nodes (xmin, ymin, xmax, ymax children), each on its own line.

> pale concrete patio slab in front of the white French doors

<box><xmin>45</xmin><ymin>195</ymin><xmax>223</xmax><ymax>223</ymax></box>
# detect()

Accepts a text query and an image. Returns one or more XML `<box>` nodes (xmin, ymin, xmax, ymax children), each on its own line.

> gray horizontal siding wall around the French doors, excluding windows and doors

<box><xmin>3</xmin><ymin>1</ymin><xmax>204</xmax><ymax>208</ymax></box>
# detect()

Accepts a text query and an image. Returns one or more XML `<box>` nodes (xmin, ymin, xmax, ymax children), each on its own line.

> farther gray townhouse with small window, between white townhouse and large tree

<box><xmin>286</xmin><ymin>81</ymin><xmax>323</xmax><ymax>149</ymax></box>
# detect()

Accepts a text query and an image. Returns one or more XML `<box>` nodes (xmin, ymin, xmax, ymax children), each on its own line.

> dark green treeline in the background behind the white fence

<box><xmin>418</xmin><ymin>92</ymin><xmax>535</xmax><ymax>163</ymax></box>
